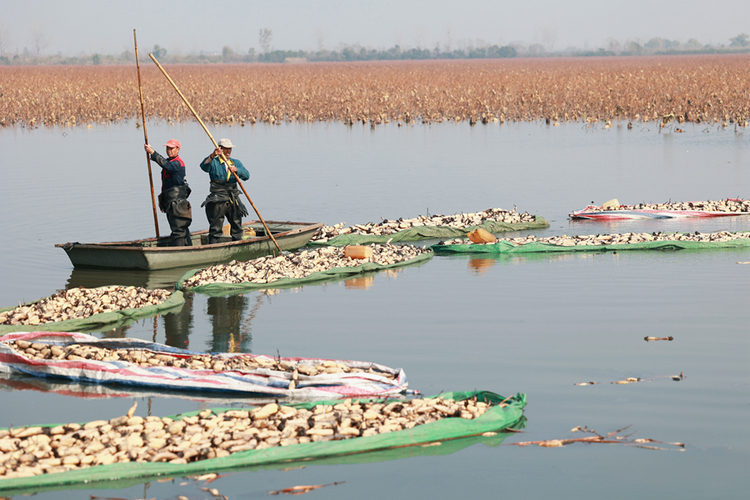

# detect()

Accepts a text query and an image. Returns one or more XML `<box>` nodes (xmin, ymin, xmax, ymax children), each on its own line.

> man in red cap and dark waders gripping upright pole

<box><xmin>145</xmin><ymin>139</ymin><xmax>193</xmax><ymax>247</ymax></box>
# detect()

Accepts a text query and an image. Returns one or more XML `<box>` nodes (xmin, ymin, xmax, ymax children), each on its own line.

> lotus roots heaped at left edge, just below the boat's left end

<box><xmin>0</xmin><ymin>286</ymin><xmax>172</xmax><ymax>326</ymax></box>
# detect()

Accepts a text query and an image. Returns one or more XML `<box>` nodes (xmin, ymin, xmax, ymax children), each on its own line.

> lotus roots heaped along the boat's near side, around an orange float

<box><xmin>182</xmin><ymin>245</ymin><xmax>430</xmax><ymax>288</ymax></box>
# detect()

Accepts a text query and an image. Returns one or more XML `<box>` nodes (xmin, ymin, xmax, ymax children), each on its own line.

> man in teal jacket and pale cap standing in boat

<box><xmin>201</xmin><ymin>139</ymin><xmax>250</xmax><ymax>244</ymax></box>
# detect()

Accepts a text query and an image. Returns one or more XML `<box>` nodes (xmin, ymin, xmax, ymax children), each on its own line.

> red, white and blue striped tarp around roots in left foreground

<box><xmin>0</xmin><ymin>332</ymin><xmax>409</xmax><ymax>400</ymax></box>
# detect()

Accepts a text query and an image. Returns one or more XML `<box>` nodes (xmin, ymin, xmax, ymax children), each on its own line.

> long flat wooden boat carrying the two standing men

<box><xmin>55</xmin><ymin>221</ymin><xmax>323</xmax><ymax>271</ymax></box>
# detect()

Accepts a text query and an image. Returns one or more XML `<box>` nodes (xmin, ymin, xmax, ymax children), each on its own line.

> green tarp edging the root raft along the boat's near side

<box><xmin>175</xmin><ymin>252</ymin><xmax>434</xmax><ymax>295</ymax></box>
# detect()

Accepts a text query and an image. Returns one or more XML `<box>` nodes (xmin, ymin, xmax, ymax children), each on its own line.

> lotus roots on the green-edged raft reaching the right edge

<box><xmin>444</xmin><ymin>231</ymin><xmax>750</xmax><ymax>247</ymax></box>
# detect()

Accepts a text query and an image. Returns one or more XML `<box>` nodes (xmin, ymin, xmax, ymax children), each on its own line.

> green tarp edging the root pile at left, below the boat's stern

<box><xmin>0</xmin><ymin>287</ymin><xmax>185</xmax><ymax>335</ymax></box>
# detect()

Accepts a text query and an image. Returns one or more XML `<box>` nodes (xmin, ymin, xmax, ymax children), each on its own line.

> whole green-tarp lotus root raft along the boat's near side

<box><xmin>175</xmin><ymin>244</ymin><xmax>433</xmax><ymax>294</ymax></box>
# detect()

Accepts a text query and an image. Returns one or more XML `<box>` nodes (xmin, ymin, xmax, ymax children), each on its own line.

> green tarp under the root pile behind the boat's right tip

<box><xmin>307</xmin><ymin>217</ymin><xmax>549</xmax><ymax>247</ymax></box>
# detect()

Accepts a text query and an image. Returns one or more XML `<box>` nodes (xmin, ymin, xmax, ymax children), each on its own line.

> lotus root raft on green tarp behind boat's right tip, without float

<box><xmin>308</xmin><ymin>208</ymin><xmax>549</xmax><ymax>247</ymax></box>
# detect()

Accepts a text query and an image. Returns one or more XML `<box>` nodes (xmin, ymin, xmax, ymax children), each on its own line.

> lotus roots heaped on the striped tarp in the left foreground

<box><xmin>5</xmin><ymin>340</ymin><xmax>396</xmax><ymax>381</ymax></box>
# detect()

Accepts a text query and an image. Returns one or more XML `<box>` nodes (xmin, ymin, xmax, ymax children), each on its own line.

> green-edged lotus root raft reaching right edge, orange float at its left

<box><xmin>431</xmin><ymin>231</ymin><xmax>750</xmax><ymax>254</ymax></box>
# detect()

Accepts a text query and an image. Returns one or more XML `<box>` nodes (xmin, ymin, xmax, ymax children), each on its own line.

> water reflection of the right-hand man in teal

<box><xmin>206</xmin><ymin>295</ymin><xmax>253</xmax><ymax>352</ymax></box>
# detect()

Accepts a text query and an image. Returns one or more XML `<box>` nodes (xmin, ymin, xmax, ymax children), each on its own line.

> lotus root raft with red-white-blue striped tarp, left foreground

<box><xmin>0</xmin><ymin>332</ymin><xmax>409</xmax><ymax>399</ymax></box>
